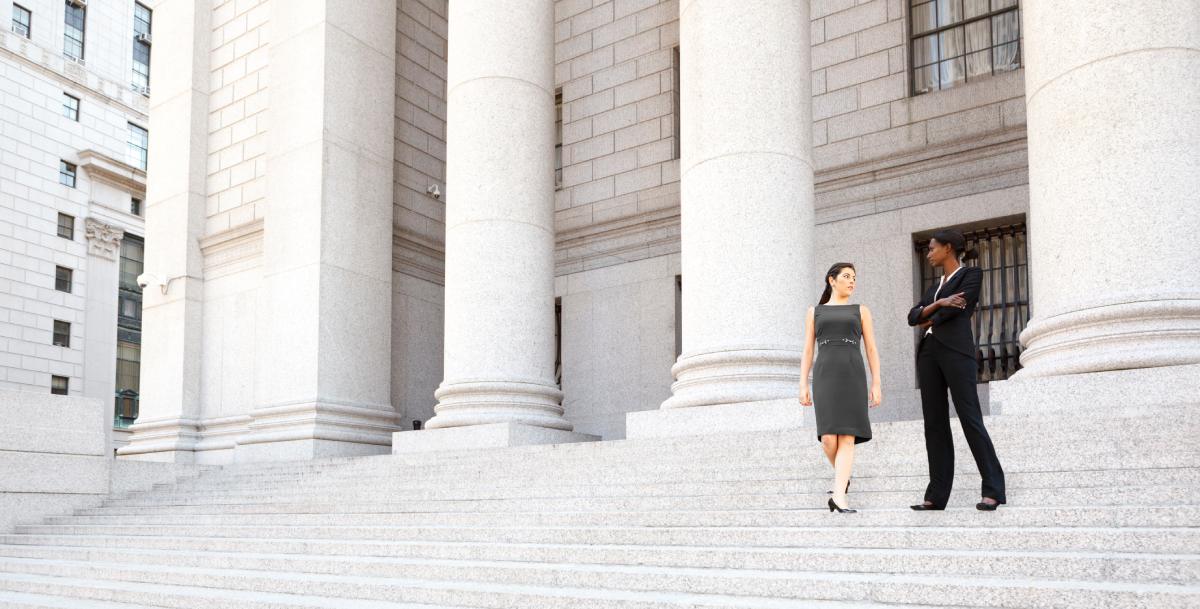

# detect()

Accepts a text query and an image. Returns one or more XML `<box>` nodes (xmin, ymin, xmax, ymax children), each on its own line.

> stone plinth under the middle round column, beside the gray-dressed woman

<box><xmin>625</xmin><ymin>398</ymin><xmax>816</xmax><ymax>440</ymax></box>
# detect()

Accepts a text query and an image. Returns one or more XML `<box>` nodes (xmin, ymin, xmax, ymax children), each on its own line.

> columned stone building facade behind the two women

<box><xmin>110</xmin><ymin>0</ymin><xmax>1200</xmax><ymax>463</ymax></box>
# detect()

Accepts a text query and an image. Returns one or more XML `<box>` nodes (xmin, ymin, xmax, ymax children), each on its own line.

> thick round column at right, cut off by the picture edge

<box><xmin>1015</xmin><ymin>0</ymin><xmax>1200</xmax><ymax>376</ymax></box>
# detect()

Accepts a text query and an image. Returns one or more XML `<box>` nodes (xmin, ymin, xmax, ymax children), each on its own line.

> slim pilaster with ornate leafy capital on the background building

<box><xmin>83</xmin><ymin>217</ymin><xmax>125</xmax><ymax>457</ymax></box>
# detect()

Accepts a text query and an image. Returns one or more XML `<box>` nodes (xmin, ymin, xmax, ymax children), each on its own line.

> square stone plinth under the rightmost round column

<box><xmin>989</xmin><ymin>364</ymin><xmax>1200</xmax><ymax>417</ymax></box>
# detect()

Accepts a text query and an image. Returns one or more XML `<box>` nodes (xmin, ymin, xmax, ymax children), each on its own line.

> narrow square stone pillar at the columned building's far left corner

<box><xmin>117</xmin><ymin>0</ymin><xmax>212</xmax><ymax>463</ymax></box>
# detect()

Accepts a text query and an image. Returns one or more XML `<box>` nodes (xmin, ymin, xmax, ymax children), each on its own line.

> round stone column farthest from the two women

<box><xmin>427</xmin><ymin>0</ymin><xmax>571</xmax><ymax>430</ymax></box>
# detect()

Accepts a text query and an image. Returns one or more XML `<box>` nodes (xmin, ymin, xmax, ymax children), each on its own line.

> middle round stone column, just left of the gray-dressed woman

<box><xmin>662</xmin><ymin>0</ymin><xmax>820</xmax><ymax>409</ymax></box>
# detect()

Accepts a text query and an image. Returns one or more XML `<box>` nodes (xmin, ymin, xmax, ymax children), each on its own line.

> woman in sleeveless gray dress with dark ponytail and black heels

<box><xmin>800</xmin><ymin>263</ymin><xmax>883</xmax><ymax>513</ymax></box>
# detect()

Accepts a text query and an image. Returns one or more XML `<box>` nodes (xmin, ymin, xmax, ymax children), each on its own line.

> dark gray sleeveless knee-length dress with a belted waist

<box><xmin>812</xmin><ymin>305</ymin><xmax>871</xmax><ymax>444</ymax></box>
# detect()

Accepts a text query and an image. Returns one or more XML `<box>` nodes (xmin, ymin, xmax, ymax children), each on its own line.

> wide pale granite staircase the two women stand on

<box><xmin>0</xmin><ymin>408</ymin><xmax>1200</xmax><ymax>609</ymax></box>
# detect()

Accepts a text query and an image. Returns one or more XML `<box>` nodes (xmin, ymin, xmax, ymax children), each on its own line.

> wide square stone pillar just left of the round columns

<box><xmin>235</xmin><ymin>0</ymin><xmax>397</xmax><ymax>462</ymax></box>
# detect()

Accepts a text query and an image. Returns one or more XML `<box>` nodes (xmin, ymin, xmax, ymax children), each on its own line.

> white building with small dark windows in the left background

<box><xmin>0</xmin><ymin>0</ymin><xmax>152</xmax><ymax>445</ymax></box>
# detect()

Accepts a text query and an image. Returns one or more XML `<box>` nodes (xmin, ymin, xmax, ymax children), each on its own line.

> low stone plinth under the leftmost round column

<box><xmin>391</xmin><ymin>423</ymin><xmax>600</xmax><ymax>454</ymax></box>
